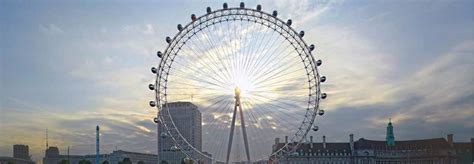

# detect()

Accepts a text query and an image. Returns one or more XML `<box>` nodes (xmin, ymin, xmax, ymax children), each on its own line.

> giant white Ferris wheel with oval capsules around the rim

<box><xmin>148</xmin><ymin>2</ymin><xmax>327</xmax><ymax>163</ymax></box>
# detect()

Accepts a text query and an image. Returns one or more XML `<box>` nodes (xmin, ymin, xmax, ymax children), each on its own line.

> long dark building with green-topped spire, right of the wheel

<box><xmin>273</xmin><ymin>121</ymin><xmax>474</xmax><ymax>164</ymax></box>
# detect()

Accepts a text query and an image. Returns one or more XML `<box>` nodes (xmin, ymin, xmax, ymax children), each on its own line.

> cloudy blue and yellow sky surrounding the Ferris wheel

<box><xmin>0</xmin><ymin>0</ymin><xmax>474</xmax><ymax>161</ymax></box>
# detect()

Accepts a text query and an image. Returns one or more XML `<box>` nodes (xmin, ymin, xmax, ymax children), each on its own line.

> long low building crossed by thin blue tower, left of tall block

<box><xmin>43</xmin><ymin>147</ymin><xmax>158</xmax><ymax>164</ymax></box>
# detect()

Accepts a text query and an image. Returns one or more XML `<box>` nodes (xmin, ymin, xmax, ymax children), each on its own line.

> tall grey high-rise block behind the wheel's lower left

<box><xmin>158</xmin><ymin>102</ymin><xmax>202</xmax><ymax>164</ymax></box>
